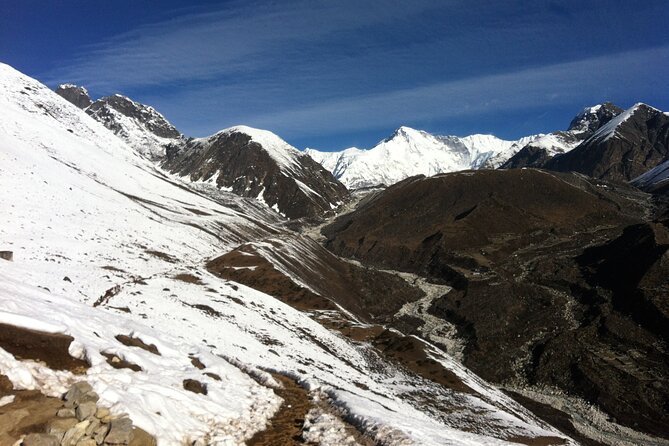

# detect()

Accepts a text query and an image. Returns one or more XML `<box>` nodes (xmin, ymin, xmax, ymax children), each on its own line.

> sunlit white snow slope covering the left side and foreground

<box><xmin>0</xmin><ymin>64</ymin><xmax>576</xmax><ymax>445</ymax></box>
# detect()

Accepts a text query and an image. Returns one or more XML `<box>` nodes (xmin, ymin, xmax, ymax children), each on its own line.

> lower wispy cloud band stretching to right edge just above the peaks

<box><xmin>155</xmin><ymin>46</ymin><xmax>669</xmax><ymax>138</ymax></box>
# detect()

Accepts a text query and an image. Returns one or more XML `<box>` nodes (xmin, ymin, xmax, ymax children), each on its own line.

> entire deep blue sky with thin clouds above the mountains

<box><xmin>0</xmin><ymin>0</ymin><xmax>669</xmax><ymax>150</ymax></box>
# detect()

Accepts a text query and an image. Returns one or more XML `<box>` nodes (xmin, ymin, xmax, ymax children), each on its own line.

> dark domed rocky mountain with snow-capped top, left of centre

<box><xmin>162</xmin><ymin>126</ymin><xmax>348</xmax><ymax>219</ymax></box>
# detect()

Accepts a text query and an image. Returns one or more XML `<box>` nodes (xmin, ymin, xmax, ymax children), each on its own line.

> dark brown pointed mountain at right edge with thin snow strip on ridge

<box><xmin>544</xmin><ymin>104</ymin><xmax>669</xmax><ymax>181</ymax></box>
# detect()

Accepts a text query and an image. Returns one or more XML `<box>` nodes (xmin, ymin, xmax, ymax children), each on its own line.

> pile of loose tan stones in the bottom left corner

<box><xmin>22</xmin><ymin>381</ymin><xmax>155</xmax><ymax>446</ymax></box>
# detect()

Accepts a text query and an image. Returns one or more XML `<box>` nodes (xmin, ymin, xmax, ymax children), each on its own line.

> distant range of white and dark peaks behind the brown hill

<box><xmin>306</xmin><ymin>102</ymin><xmax>666</xmax><ymax>189</ymax></box>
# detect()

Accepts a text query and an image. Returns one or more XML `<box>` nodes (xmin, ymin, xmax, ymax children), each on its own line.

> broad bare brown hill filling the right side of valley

<box><xmin>323</xmin><ymin>169</ymin><xmax>669</xmax><ymax>438</ymax></box>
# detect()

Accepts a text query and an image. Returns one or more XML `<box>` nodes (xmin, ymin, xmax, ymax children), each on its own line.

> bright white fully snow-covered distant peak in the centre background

<box><xmin>307</xmin><ymin>127</ymin><xmax>533</xmax><ymax>189</ymax></box>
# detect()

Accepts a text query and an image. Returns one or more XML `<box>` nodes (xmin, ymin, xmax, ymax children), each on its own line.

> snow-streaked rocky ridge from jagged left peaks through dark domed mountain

<box><xmin>56</xmin><ymin>84</ymin><xmax>348</xmax><ymax>219</ymax></box>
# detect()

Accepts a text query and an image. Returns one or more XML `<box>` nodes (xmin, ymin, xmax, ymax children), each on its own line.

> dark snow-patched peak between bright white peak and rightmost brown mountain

<box><xmin>500</xmin><ymin>102</ymin><xmax>623</xmax><ymax>169</ymax></box>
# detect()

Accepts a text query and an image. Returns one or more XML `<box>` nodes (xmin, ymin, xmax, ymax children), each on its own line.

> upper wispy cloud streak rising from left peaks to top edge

<box><xmin>43</xmin><ymin>0</ymin><xmax>444</xmax><ymax>91</ymax></box>
